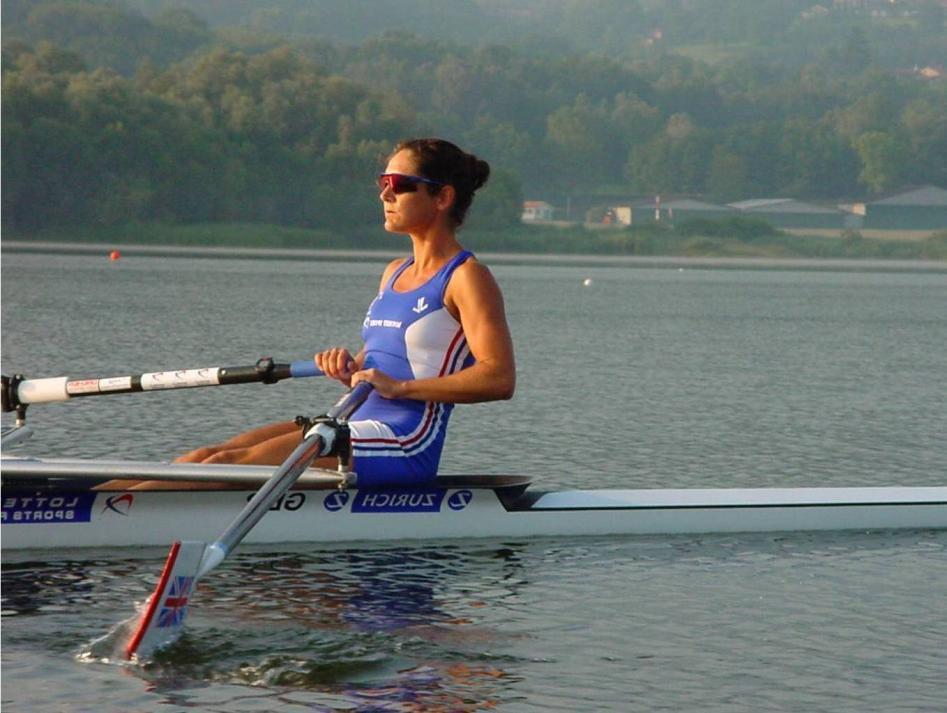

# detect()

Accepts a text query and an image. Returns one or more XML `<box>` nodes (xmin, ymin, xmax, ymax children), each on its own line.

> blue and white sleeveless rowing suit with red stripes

<box><xmin>349</xmin><ymin>250</ymin><xmax>474</xmax><ymax>485</ymax></box>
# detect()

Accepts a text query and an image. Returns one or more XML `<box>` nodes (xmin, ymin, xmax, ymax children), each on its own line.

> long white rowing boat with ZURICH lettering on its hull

<box><xmin>2</xmin><ymin>456</ymin><xmax>947</xmax><ymax>550</ymax></box>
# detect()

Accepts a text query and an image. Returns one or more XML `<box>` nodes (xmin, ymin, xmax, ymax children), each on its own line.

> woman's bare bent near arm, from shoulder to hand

<box><xmin>352</xmin><ymin>259</ymin><xmax>516</xmax><ymax>403</ymax></box>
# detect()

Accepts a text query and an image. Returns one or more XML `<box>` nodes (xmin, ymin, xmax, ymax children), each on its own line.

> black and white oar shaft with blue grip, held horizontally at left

<box><xmin>0</xmin><ymin>357</ymin><xmax>322</xmax><ymax>412</ymax></box>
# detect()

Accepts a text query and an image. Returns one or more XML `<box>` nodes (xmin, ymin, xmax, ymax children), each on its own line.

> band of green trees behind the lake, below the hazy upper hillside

<box><xmin>2</xmin><ymin>0</ymin><xmax>947</xmax><ymax>229</ymax></box>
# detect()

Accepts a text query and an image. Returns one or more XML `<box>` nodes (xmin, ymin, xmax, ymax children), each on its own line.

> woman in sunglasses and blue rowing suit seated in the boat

<box><xmin>126</xmin><ymin>139</ymin><xmax>516</xmax><ymax>489</ymax></box>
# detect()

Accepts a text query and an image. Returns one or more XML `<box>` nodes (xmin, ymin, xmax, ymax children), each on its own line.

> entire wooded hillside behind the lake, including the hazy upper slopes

<box><xmin>2</xmin><ymin>0</ymin><xmax>947</xmax><ymax>247</ymax></box>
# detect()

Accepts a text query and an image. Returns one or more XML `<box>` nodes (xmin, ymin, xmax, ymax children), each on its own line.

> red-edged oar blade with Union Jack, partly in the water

<box><xmin>125</xmin><ymin>542</ymin><xmax>206</xmax><ymax>659</ymax></box>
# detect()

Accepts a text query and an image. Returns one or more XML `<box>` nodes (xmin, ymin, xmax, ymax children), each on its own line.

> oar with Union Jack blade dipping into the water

<box><xmin>125</xmin><ymin>381</ymin><xmax>372</xmax><ymax>658</ymax></box>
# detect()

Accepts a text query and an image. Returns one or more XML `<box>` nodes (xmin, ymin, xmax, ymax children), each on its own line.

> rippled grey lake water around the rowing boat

<box><xmin>0</xmin><ymin>252</ymin><xmax>947</xmax><ymax>712</ymax></box>
